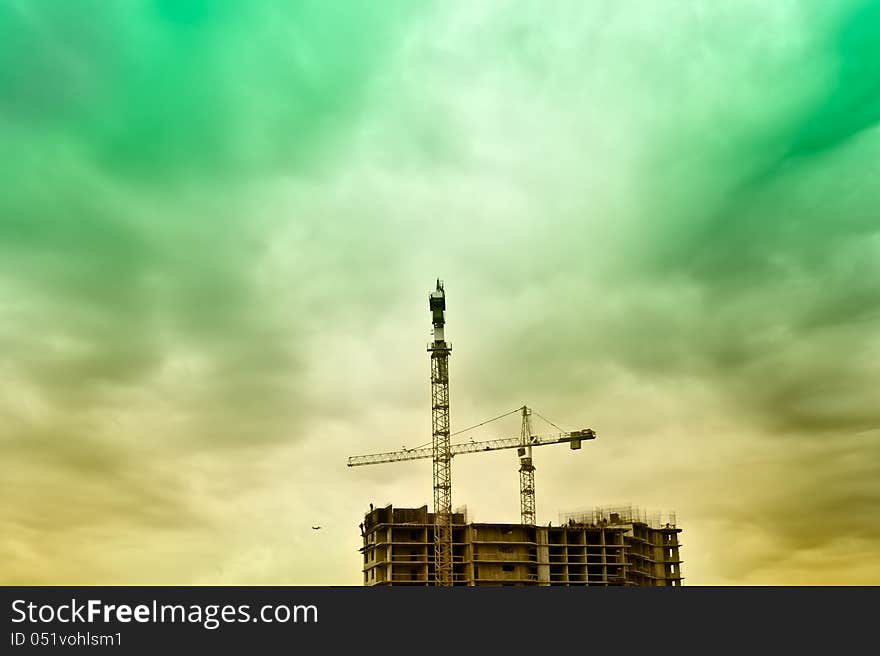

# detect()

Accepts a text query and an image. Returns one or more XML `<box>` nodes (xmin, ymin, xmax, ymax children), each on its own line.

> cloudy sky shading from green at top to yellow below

<box><xmin>0</xmin><ymin>0</ymin><xmax>880</xmax><ymax>585</ymax></box>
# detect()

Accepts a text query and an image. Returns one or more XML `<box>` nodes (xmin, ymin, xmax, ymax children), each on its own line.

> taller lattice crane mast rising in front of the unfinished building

<box><xmin>428</xmin><ymin>279</ymin><xmax>452</xmax><ymax>586</ymax></box>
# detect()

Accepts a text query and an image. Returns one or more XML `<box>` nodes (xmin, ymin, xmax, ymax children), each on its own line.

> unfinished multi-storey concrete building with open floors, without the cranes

<box><xmin>361</xmin><ymin>505</ymin><xmax>682</xmax><ymax>586</ymax></box>
